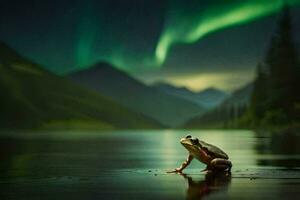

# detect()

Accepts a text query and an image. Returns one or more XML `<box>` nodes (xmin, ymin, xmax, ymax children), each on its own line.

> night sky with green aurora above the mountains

<box><xmin>0</xmin><ymin>0</ymin><xmax>300</xmax><ymax>90</ymax></box>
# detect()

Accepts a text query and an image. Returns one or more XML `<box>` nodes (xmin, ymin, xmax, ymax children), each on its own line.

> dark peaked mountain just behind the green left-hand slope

<box><xmin>69</xmin><ymin>62</ymin><xmax>204</xmax><ymax>127</ymax></box>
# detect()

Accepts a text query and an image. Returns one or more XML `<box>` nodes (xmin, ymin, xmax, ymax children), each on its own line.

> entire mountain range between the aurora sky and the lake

<box><xmin>0</xmin><ymin>42</ymin><xmax>252</xmax><ymax>129</ymax></box>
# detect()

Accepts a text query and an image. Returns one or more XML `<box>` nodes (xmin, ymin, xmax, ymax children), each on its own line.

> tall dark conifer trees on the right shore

<box><xmin>244</xmin><ymin>7</ymin><xmax>300</xmax><ymax>127</ymax></box>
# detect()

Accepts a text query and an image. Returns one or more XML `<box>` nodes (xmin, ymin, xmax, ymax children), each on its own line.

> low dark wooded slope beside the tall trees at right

<box><xmin>184</xmin><ymin>83</ymin><xmax>253</xmax><ymax>128</ymax></box>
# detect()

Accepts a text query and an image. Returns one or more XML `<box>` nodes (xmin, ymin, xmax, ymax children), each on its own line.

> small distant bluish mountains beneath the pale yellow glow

<box><xmin>153</xmin><ymin>83</ymin><xmax>228</xmax><ymax>109</ymax></box>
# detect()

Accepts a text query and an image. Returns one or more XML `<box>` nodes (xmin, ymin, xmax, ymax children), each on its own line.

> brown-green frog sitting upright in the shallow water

<box><xmin>171</xmin><ymin>135</ymin><xmax>232</xmax><ymax>173</ymax></box>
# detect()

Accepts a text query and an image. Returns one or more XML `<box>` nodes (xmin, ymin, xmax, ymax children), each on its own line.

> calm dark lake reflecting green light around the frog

<box><xmin>0</xmin><ymin>130</ymin><xmax>300</xmax><ymax>200</ymax></box>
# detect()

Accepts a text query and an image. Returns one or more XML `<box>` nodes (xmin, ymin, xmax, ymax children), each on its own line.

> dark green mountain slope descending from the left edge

<box><xmin>0</xmin><ymin>42</ymin><xmax>161</xmax><ymax>128</ymax></box>
